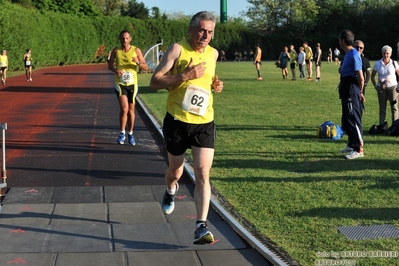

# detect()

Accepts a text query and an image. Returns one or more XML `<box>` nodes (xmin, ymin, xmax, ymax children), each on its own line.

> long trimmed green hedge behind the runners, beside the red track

<box><xmin>0</xmin><ymin>2</ymin><xmax>268</xmax><ymax>71</ymax></box>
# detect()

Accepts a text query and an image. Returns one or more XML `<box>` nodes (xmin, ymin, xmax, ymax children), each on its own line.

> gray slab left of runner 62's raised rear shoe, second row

<box><xmin>109</xmin><ymin>202</ymin><xmax>165</xmax><ymax>224</ymax></box>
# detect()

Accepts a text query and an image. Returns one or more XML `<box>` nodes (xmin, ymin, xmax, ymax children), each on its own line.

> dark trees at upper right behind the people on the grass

<box><xmin>243</xmin><ymin>0</ymin><xmax>399</xmax><ymax>60</ymax></box>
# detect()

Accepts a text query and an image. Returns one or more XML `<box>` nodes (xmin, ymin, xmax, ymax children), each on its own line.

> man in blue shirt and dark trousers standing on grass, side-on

<box><xmin>339</xmin><ymin>30</ymin><xmax>365</xmax><ymax>159</ymax></box>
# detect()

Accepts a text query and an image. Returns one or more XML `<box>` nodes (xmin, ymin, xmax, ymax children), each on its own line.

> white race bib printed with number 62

<box><xmin>182</xmin><ymin>85</ymin><xmax>210</xmax><ymax>116</ymax></box>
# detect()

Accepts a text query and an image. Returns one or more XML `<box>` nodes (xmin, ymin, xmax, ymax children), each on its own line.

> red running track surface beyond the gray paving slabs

<box><xmin>0</xmin><ymin>64</ymin><xmax>167</xmax><ymax>187</ymax></box>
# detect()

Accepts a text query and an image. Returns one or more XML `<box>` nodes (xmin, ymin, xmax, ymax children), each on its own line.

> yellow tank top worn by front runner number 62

<box><xmin>166</xmin><ymin>41</ymin><xmax>216</xmax><ymax>124</ymax></box>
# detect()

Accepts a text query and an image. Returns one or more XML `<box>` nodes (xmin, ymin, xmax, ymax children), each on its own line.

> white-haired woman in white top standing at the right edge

<box><xmin>371</xmin><ymin>45</ymin><xmax>399</xmax><ymax>124</ymax></box>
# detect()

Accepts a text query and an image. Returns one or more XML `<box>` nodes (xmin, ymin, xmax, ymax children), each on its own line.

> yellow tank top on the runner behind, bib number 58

<box><xmin>115</xmin><ymin>45</ymin><xmax>137</xmax><ymax>87</ymax></box>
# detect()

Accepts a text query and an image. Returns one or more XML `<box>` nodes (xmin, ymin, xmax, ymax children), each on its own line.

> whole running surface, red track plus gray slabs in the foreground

<box><xmin>0</xmin><ymin>65</ymin><xmax>269</xmax><ymax>266</ymax></box>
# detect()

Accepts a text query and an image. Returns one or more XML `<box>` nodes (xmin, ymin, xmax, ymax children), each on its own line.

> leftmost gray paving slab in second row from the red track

<box><xmin>0</xmin><ymin>204</ymin><xmax>54</xmax><ymax>225</ymax></box>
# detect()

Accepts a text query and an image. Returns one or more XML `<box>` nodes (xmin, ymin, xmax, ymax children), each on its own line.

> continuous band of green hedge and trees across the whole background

<box><xmin>0</xmin><ymin>0</ymin><xmax>399</xmax><ymax>66</ymax></box>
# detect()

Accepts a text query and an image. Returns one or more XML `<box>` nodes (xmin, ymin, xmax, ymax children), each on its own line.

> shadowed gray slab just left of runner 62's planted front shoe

<box><xmin>112</xmin><ymin>223</ymin><xmax>185</xmax><ymax>251</ymax></box>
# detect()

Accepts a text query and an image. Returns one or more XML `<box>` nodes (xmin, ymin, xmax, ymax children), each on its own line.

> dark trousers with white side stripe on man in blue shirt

<box><xmin>341</xmin><ymin>84</ymin><xmax>363</xmax><ymax>152</ymax></box>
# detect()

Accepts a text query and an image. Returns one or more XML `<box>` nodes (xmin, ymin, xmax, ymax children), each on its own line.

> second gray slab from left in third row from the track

<box><xmin>46</xmin><ymin>224</ymin><xmax>112</xmax><ymax>253</ymax></box>
